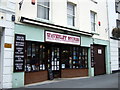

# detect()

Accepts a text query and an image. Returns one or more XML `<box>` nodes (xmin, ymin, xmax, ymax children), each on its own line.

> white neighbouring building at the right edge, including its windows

<box><xmin>108</xmin><ymin>0</ymin><xmax>120</xmax><ymax>72</ymax></box>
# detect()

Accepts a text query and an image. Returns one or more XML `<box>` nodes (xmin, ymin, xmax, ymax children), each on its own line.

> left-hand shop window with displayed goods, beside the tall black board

<box><xmin>25</xmin><ymin>42</ymin><xmax>46</xmax><ymax>72</ymax></box>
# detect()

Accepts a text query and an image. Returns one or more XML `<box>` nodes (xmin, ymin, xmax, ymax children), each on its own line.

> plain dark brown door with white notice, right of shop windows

<box><xmin>93</xmin><ymin>45</ymin><xmax>106</xmax><ymax>75</ymax></box>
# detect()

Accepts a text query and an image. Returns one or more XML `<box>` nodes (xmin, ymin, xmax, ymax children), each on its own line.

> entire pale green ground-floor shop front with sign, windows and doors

<box><xmin>13</xmin><ymin>24</ymin><xmax>110</xmax><ymax>88</ymax></box>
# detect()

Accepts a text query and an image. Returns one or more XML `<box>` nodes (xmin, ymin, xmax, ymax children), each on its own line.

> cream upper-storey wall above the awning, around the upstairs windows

<box><xmin>16</xmin><ymin>0</ymin><xmax>108</xmax><ymax>40</ymax></box>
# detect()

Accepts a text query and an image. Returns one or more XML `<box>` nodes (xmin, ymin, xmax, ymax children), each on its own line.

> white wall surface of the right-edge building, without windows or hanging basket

<box><xmin>108</xmin><ymin>0</ymin><xmax>118</xmax><ymax>72</ymax></box>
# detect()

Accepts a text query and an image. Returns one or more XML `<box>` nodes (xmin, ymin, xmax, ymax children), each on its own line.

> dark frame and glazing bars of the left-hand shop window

<box><xmin>25</xmin><ymin>41</ymin><xmax>47</xmax><ymax>72</ymax></box>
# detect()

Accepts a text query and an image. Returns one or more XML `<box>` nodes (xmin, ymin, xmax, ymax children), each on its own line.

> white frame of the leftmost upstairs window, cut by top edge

<box><xmin>37</xmin><ymin>0</ymin><xmax>51</xmax><ymax>21</ymax></box>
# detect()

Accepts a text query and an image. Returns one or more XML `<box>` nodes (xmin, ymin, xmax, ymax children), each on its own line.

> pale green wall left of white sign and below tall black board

<box><xmin>12</xmin><ymin>24</ymin><xmax>44</xmax><ymax>88</ymax></box>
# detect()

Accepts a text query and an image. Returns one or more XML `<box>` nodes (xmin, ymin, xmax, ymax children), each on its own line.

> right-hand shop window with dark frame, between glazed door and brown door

<box><xmin>61</xmin><ymin>46</ymin><xmax>88</xmax><ymax>69</ymax></box>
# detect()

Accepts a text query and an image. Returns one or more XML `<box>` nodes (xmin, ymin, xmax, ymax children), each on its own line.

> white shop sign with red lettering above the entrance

<box><xmin>45</xmin><ymin>31</ymin><xmax>80</xmax><ymax>45</ymax></box>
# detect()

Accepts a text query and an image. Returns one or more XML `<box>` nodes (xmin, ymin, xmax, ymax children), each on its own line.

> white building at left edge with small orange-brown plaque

<box><xmin>0</xmin><ymin>0</ymin><xmax>15</xmax><ymax>89</ymax></box>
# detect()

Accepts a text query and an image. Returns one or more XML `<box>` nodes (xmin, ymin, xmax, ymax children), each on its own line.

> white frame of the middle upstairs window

<box><xmin>67</xmin><ymin>2</ymin><xmax>76</xmax><ymax>27</ymax></box>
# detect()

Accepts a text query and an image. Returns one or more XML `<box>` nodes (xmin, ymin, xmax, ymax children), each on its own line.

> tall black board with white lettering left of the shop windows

<box><xmin>14</xmin><ymin>34</ymin><xmax>25</xmax><ymax>72</ymax></box>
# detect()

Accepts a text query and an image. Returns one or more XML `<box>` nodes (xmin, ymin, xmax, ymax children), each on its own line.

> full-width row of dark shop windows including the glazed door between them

<box><xmin>25</xmin><ymin>41</ymin><xmax>88</xmax><ymax>72</ymax></box>
